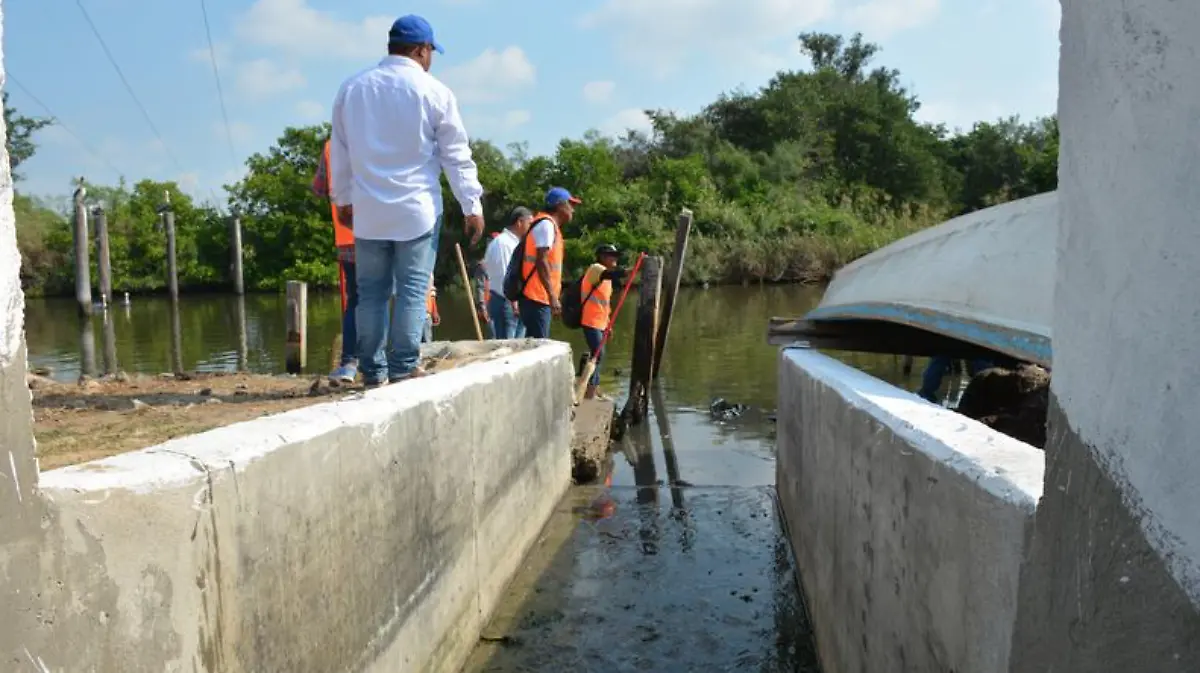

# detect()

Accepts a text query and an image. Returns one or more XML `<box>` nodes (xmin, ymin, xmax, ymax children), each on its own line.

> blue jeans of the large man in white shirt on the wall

<box><xmin>354</xmin><ymin>217</ymin><xmax>442</xmax><ymax>384</ymax></box>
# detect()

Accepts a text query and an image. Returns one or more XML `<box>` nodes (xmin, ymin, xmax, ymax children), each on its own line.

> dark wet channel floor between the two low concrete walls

<box><xmin>464</xmin><ymin>487</ymin><xmax>832</xmax><ymax>673</ymax></box>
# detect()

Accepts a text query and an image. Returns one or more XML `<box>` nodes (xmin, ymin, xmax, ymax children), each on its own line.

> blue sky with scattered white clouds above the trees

<box><xmin>4</xmin><ymin>0</ymin><xmax>1058</xmax><ymax>199</ymax></box>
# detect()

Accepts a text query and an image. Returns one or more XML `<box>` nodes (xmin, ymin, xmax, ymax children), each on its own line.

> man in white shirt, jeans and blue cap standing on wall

<box><xmin>330</xmin><ymin>14</ymin><xmax>484</xmax><ymax>387</ymax></box>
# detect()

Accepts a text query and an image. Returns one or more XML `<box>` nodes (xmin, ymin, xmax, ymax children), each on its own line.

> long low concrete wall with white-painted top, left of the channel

<box><xmin>0</xmin><ymin>342</ymin><xmax>571</xmax><ymax>673</ymax></box>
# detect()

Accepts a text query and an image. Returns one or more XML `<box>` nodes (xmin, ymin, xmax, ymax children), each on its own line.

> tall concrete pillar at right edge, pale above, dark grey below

<box><xmin>1014</xmin><ymin>0</ymin><xmax>1200</xmax><ymax>673</ymax></box>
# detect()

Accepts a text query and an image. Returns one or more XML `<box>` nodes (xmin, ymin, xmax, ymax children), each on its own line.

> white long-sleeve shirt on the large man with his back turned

<box><xmin>329</xmin><ymin>55</ymin><xmax>484</xmax><ymax>241</ymax></box>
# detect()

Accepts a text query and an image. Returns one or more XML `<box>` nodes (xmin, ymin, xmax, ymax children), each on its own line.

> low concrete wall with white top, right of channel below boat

<box><xmin>776</xmin><ymin>349</ymin><xmax>1044</xmax><ymax>673</ymax></box>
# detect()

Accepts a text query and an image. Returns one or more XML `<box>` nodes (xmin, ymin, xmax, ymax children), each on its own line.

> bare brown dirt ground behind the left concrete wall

<box><xmin>29</xmin><ymin>344</ymin><xmax>512</xmax><ymax>470</ymax></box>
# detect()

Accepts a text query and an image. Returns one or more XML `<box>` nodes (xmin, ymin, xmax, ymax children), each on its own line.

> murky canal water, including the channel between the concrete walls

<box><xmin>26</xmin><ymin>286</ymin><xmax>924</xmax><ymax>673</ymax></box>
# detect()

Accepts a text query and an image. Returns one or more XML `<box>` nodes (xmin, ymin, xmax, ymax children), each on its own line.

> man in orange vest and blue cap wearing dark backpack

<box><xmin>520</xmin><ymin>187</ymin><xmax>583</xmax><ymax>338</ymax></box>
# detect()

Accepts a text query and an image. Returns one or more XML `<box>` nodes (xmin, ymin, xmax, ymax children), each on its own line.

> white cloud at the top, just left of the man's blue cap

<box><xmin>234</xmin><ymin>0</ymin><xmax>396</xmax><ymax>60</ymax></box>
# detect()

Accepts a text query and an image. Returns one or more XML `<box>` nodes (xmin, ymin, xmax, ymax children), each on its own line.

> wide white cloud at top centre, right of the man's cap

<box><xmin>581</xmin><ymin>0</ymin><xmax>833</xmax><ymax>77</ymax></box>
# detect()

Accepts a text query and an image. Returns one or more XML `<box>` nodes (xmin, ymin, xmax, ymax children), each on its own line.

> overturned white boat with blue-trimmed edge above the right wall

<box><xmin>769</xmin><ymin>192</ymin><xmax>1058</xmax><ymax>367</ymax></box>
